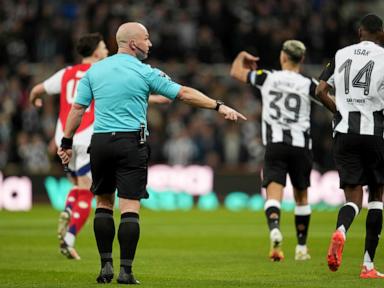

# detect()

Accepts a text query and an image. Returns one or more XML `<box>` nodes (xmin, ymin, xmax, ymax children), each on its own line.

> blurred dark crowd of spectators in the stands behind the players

<box><xmin>0</xmin><ymin>0</ymin><xmax>384</xmax><ymax>173</ymax></box>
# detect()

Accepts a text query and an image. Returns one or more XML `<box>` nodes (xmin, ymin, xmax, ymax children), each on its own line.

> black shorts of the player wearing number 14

<box><xmin>333</xmin><ymin>133</ymin><xmax>384</xmax><ymax>188</ymax></box>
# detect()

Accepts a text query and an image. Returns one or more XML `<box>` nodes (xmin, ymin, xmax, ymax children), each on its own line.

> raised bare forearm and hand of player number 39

<box><xmin>230</xmin><ymin>51</ymin><xmax>259</xmax><ymax>83</ymax></box>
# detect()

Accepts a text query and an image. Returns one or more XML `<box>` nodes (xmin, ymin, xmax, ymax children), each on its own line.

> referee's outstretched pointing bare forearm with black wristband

<box><xmin>177</xmin><ymin>86</ymin><xmax>247</xmax><ymax>121</ymax></box>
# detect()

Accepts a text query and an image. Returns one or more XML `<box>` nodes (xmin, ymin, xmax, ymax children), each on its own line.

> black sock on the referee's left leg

<box><xmin>93</xmin><ymin>208</ymin><xmax>115</xmax><ymax>267</ymax></box>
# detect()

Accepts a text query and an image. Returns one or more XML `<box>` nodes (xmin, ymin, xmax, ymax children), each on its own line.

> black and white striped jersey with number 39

<box><xmin>248</xmin><ymin>70</ymin><xmax>317</xmax><ymax>149</ymax></box>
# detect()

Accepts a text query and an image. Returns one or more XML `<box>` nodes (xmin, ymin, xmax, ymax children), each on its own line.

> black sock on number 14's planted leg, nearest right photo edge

<box><xmin>364</xmin><ymin>202</ymin><xmax>383</xmax><ymax>262</ymax></box>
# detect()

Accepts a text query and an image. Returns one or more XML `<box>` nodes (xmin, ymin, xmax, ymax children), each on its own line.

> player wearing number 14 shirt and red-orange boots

<box><xmin>317</xmin><ymin>14</ymin><xmax>384</xmax><ymax>278</ymax></box>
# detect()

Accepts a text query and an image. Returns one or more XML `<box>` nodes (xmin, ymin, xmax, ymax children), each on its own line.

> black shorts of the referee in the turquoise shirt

<box><xmin>90</xmin><ymin>132</ymin><xmax>149</xmax><ymax>200</ymax></box>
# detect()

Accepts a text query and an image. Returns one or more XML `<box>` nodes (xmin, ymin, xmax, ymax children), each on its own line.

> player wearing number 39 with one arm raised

<box><xmin>230</xmin><ymin>40</ymin><xmax>332</xmax><ymax>261</ymax></box>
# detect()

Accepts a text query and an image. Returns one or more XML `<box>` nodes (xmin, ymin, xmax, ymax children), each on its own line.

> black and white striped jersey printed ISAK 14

<box><xmin>321</xmin><ymin>41</ymin><xmax>384</xmax><ymax>137</ymax></box>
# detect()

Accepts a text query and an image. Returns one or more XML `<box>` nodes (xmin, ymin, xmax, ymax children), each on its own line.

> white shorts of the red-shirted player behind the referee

<box><xmin>68</xmin><ymin>145</ymin><xmax>91</xmax><ymax>177</ymax></box>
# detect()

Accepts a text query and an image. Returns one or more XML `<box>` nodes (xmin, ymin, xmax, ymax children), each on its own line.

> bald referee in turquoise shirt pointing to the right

<box><xmin>57</xmin><ymin>22</ymin><xmax>246</xmax><ymax>284</ymax></box>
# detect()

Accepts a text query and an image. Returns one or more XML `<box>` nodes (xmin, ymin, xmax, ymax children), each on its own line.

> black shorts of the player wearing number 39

<box><xmin>263</xmin><ymin>143</ymin><xmax>313</xmax><ymax>190</ymax></box>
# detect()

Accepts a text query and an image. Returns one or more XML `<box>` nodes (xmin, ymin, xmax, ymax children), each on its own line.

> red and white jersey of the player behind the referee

<box><xmin>43</xmin><ymin>64</ymin><xmax>95</xmax><ymax>146</ymax></box>
